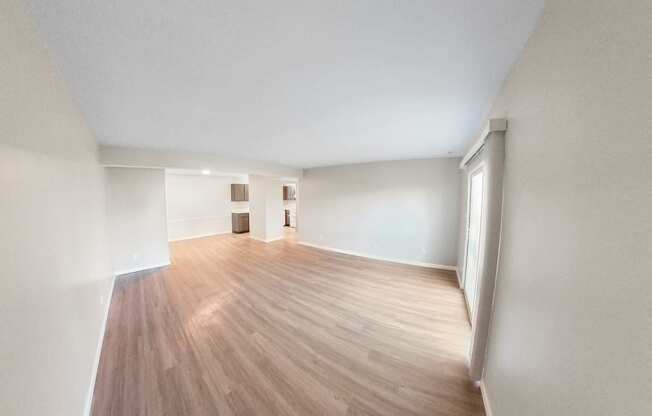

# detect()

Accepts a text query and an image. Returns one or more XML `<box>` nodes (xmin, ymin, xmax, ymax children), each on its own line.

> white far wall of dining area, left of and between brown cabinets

<box><xmin>166</xmin><ymin>173</ymin><xmax>249</xmax><ymax>241</ymax></box>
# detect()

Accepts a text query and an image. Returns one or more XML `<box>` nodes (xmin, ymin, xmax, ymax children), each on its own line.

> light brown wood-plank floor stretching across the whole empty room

<box><xmin>93</xmin><ymin>232</ymin><xmax>484</xmax><ymax>416</ymax></box>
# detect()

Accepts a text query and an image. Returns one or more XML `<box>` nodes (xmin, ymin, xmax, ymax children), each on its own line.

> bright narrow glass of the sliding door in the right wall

<box><xmin>464</xmin><ymin>167</ymin><xmax>484</xmax><ymax>323</ymax></box>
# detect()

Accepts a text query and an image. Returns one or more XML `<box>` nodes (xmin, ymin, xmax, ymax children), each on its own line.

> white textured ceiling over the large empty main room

<box><xmin>28</xmin><ymin>0</ymin><xmax>544</xmax><ymax>167</ymax></box>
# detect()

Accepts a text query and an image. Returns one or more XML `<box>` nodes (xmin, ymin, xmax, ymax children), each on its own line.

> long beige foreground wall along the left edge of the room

<box><xmin>0</xmin><ymin>0</ymin><xmax>112</xmax><ymax>416</ymax></box>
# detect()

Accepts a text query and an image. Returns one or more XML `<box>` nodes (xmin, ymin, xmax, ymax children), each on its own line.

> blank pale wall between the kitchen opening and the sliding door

<box><xmin>298</xmin><ymin>158</ymin><xmax>460</xmax><ymax>266</ymax></box>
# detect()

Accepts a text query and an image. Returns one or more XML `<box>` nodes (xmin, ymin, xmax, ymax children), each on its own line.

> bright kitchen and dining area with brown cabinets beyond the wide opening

<box><xmin>165</xmin><ymin>169</ymin><xmax>298</xmax><ymax>242</ymax></box>
